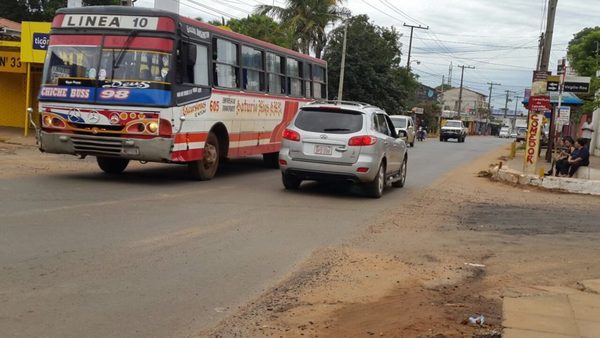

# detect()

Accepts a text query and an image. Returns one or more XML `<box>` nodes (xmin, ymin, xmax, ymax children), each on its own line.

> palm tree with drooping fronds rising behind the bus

<box><xmin>256</xmin><ymin>0</ymin><xmax>350</xmax><ymax>58</ymax></box>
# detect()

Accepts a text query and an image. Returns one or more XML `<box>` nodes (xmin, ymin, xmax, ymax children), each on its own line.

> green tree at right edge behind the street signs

<box><xmin>567</xmin><ymin>27</ymin><xmax>600</xmax><ymax>114</ymax></box>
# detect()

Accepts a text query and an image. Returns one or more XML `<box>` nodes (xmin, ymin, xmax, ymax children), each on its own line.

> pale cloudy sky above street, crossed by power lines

<box><xmin>135</xmin><ymin>0</ymin><xmax>600</xmax><ymax>110</ymax></box>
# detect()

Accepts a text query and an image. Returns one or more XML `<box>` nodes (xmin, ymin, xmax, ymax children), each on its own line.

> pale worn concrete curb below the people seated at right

<box><xmin>488</xmin><ymin>165</ymin><xmax>600</xmax><ymax>196</ymax></box>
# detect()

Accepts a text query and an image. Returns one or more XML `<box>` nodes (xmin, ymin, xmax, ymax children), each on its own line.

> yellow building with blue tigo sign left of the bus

<box><xmin>0</xmin><ymin>18</ymin><xmax>50</xmax><ymax>134</ymax></box>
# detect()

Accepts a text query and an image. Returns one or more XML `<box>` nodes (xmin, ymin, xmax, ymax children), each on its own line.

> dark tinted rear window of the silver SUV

<box><xmin>294</xmin><ymin>109</ymin><xmax>363</xmax><ymax>134</ymax></box>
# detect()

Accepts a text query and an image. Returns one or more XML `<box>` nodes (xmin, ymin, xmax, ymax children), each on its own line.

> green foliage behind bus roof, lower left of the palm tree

<box><xmin>227</xmin><ymin>14</ymin><xmax>293</xmax><ymax>48</ymax></box>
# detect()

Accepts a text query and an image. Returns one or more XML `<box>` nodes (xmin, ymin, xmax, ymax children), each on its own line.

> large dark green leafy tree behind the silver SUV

<box><xmin>324</xmin><ymin>15</ymin><xmax>418</xmax><ymax>114</ymax></box>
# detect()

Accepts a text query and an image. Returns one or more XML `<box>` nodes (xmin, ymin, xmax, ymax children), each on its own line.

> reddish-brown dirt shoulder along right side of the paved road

<box><xmin>204</xmin><ymin>144</ymin><xmax>600</xmax><ymax>338</ymax></box>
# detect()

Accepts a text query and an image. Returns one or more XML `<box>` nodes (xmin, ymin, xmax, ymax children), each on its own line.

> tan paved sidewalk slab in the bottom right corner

<box><xmin>502</xmin><ymin>279</ymin><xmax>600</xmax><ymax>338</ymax></box>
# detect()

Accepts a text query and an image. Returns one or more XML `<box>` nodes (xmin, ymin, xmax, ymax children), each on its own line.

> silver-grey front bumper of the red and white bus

<box><xmin>39</xmin><ymin>131</ymin><xmax>173</xmax><ymax>162</ymax></box>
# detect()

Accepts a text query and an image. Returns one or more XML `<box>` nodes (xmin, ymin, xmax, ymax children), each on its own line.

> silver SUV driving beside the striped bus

<box><xmin>279</xmin><ymin>101</ymin><xmax>407</xmax><ymax>198</ymax></box>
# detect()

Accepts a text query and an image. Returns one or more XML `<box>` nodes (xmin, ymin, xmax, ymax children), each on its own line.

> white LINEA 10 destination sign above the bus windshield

<box><xmin>62</xmin><ymin>14</ymin><xmax>158</xmax><ymax>30</ymax></box>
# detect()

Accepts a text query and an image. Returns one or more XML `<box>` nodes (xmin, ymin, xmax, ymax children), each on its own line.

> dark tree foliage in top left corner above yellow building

<box><xmin>0</xmin><ymin>0</ymin><xmax>119</xmax><ymax>22</ymax></box>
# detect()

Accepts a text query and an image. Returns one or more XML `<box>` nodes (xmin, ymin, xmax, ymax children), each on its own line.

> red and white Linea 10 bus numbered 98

<box><xmin>38</xmin><ymin>6</ymin><xmax>327</xmax><ymax>180</ymax></box>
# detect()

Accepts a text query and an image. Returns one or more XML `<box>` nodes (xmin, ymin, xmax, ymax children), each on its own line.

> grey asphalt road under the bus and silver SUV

<box><xmin>0</xmin><ymin>137</ymin><xmax>508</xmax><ymax>337</ymax></box>
